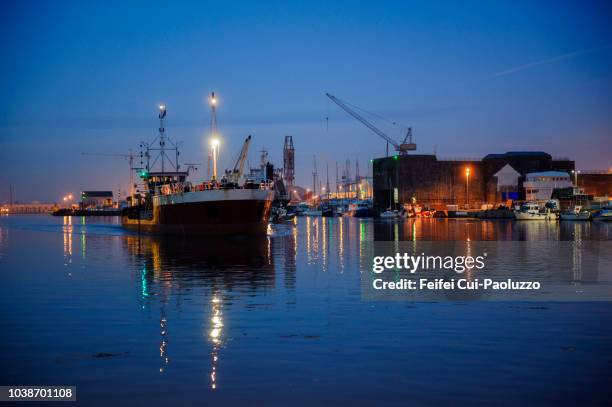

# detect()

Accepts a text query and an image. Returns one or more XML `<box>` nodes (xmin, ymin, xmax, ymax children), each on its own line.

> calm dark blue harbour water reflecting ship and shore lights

<box><xmin>0</xmin><ymin>216</ymin><xmax>612</xmax><ymax>405</ymax></box>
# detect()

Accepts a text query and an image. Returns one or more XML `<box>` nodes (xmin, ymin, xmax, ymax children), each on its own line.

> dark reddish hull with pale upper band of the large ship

<box><xmin>122</xmin><ymin>189</ymin><xmax>273</xmax><ymax>236</ymax></box>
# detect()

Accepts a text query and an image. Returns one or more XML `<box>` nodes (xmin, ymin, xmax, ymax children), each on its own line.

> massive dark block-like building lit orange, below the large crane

<box><xmin>372</xmin><ymin>151</ymin><xmax>574</xmax><ymax>210</ymax></box>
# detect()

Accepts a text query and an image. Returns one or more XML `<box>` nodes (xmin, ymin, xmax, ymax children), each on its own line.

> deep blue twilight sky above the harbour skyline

<box><xmin>0</xmin><ymin>0</ymin><xmax>612</xmax><ymax>202</ymax></box>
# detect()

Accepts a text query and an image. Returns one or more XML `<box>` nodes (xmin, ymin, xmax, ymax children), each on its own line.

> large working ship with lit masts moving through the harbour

<box><xmin>121</xmin><ymin>99</ymin><xmax>274</xmax><ymax>236</ymax></box>
